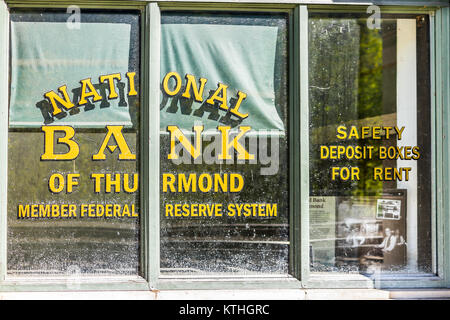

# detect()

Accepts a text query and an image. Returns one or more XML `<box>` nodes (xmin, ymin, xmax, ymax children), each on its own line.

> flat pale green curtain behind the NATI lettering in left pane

<box><xmin>10</xmin><ymin>21</ymin><xmax>131</xmax><ymax>128</ymax></box>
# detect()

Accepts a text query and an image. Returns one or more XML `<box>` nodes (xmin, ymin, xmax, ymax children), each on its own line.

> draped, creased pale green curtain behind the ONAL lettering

<box><xmin>160</xmin><ymin>20</ymin><xmax>285</xmax><ymax>133</ymax></box>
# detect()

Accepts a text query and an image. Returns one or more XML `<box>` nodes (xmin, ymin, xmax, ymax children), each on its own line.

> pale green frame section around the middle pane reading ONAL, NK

<box><xmin>149</xmin><ymin>2</ymin><xmax>308</xmax><ymax>290</ymax></box>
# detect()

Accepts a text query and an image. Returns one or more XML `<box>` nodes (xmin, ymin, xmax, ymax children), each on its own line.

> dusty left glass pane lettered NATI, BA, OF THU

<box><xmin>7</xmin><ymin>10</ymin><xmax>140</xmax><ymax>276</ymax></box>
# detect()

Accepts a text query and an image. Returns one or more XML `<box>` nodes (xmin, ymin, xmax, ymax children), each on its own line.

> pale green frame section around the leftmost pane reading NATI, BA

<box><xmin>0</xmin><ymin>1</ymin><xmax>149</xmax><ymax>291</ymax></box>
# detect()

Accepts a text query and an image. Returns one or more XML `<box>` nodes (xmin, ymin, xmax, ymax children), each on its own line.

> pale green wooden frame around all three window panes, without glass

<box><xmin>0</xmin><ymin>0</ymin><xmax>450</xmax><ymax>291</ymax></box>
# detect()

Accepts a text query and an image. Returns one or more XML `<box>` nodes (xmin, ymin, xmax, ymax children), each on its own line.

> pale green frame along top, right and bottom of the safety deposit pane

<box><xmin>302</xmin><ymin>5</ymin><xmax>450</xmax><ymax>289</ymax></box>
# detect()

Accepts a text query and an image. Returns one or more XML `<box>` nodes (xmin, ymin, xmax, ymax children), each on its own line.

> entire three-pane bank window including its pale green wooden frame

<box><xmin>0</xmin><ymin>0</ymin><xmax>449</xmax><ymax>293</ymax></box>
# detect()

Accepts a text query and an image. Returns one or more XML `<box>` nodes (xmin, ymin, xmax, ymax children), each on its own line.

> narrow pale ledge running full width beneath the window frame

<box><xmin>0</xmin><ymin>289</ymin><xmax>450</xmax><ymax>301</ymax></box>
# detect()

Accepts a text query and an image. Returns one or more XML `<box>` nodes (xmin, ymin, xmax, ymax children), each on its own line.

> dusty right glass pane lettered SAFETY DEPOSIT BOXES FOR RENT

<box><xmin>309</xmin><ymin>14</ymin><xmax>433</xmax><ymax>275</ymax></box>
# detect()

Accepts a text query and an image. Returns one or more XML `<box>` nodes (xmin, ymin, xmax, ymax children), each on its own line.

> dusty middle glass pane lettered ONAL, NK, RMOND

<box><xmin>160</xmin><ymin>12</ymin><xmax>289</xmax><ymax>276</ymax></box>
